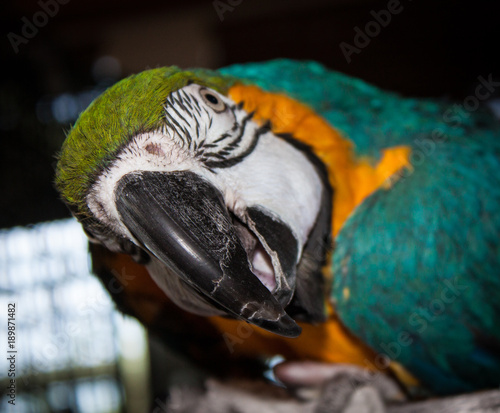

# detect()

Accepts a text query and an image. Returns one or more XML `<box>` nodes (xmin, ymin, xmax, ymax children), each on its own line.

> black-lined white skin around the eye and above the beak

<box><xmin>87</xmin><ymin>84</ymin><xmax>258</xmax><ymax>239</ymax></box>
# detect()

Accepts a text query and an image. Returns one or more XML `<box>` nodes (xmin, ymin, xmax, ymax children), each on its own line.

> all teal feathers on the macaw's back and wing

<box><xmin>222</xmin><ymin>60</ymin><xmax>500</xmax><ymax>394</ymax></box>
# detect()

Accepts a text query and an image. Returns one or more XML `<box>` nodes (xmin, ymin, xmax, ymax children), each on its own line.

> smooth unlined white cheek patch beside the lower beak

<box><xmin>213</xmin><ymin>132</ymin><xmax>323</xmax><ymax>257</ymax></box>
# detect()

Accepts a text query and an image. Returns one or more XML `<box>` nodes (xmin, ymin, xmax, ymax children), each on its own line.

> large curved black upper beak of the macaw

<box><xmin>115</xmin><ymin>171</ymin><xmax>301</xmax><ymax>337</ymax></box>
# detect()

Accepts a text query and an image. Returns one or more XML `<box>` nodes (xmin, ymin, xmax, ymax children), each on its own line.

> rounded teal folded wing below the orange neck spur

<box><xmin>333</xmin><ymin>134</ymin><xmax>500</xmax><ymax>394</ymax></box>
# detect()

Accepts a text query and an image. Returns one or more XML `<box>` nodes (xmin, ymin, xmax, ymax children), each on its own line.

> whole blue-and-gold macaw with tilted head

<box><xmin>56</xmin><ymin>59</ymin><xmax>500</xmax><ymax>395</ymax></box>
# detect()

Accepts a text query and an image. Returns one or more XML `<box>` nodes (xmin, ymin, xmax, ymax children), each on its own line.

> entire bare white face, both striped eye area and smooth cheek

<box><xmin>87</xmin><ymin>84</ymin><xmax>322</xmax><ymax>264</ymax></box>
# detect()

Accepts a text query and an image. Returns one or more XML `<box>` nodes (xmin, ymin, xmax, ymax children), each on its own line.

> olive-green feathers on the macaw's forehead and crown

<box><xmin>56</xmin><ymin>66</ymin><xmax>234</xmax><ymax>215</ymax></box>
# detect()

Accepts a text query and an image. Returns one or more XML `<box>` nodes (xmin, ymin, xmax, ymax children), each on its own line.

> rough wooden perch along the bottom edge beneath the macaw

<box><xmin>159</xmin><ymin>379</ymin><xmax>500</xmax><ymax>413</ymax></box>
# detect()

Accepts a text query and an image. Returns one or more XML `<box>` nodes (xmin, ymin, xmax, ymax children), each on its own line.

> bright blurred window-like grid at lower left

<box><xmin>0</xmin><ymin>219</ymin><xmax>147</xmax><ymax>413</ymax></box>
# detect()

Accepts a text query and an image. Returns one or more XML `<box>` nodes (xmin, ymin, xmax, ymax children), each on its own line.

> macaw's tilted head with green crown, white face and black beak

<box><xmin>56</xmin><ymin>67</ymin><xmax>331</xmax><ymax>337</ymax></box>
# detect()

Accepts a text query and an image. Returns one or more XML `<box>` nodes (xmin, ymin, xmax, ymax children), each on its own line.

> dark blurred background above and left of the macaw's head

<box><xmin>0</xmin><ymin>0</ymin><xmax>500</xmax><ymax>228</ymax></box>
